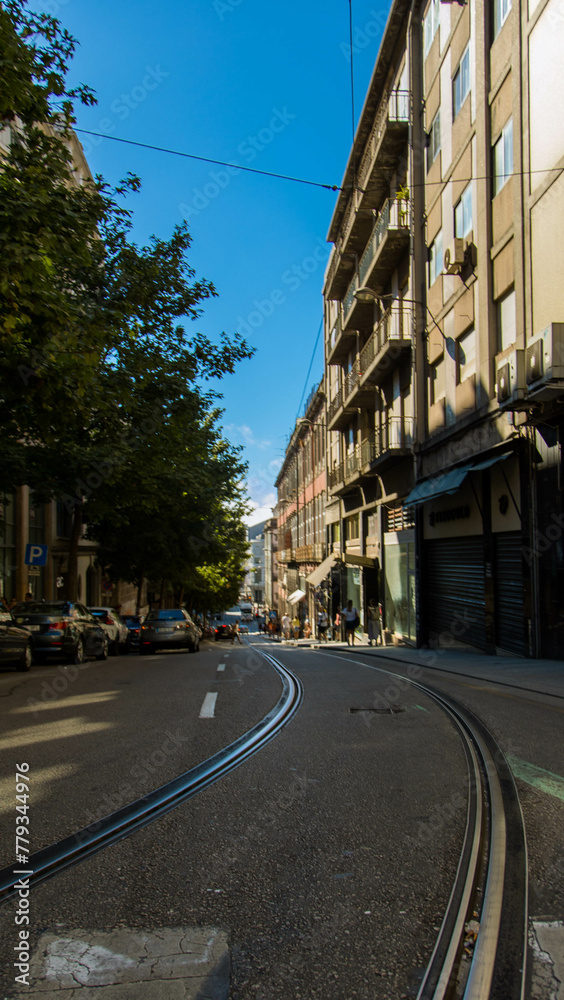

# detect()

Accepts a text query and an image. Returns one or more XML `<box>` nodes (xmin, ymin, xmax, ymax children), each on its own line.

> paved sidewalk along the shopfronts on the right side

<box><xmin>264</xmin><ymin>635</ymin><xmax>564</xmax><ymax>698</ymax></box>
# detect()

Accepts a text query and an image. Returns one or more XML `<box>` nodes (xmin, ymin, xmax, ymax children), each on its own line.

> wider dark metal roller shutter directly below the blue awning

<box><xmin>424</xmin><ymin>535</ymin><xmax>488</xmax><ymax>649</ymax></box>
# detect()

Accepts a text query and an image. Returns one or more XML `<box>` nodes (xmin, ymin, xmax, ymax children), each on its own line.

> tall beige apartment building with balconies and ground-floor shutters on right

<box><xmin>324</xmin><ymin>0</ymin><xmax>564</xmax><ymax>657</ymax></box>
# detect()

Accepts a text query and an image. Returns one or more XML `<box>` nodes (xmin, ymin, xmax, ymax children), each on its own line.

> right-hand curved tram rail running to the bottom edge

<box><xmin>316</xmin><ymin>650</ymin><xmax>528</xmax><ymax>1000</ymax></box>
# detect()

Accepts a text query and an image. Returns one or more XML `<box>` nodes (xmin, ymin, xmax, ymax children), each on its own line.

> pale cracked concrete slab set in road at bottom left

<box><xmin>17</xmin><ymin>927</ymin><xmax>230</xmax><ymax>1000</ymax></box>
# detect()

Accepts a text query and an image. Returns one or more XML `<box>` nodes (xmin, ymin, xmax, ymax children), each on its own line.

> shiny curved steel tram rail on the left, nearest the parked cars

<box><xmin>0</xmin><ymin>652</ymin><xmax>303</xmax><ymax>905</ymax></box>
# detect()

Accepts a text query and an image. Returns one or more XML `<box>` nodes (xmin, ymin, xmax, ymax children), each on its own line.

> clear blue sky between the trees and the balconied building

<box><xmin>40</xmin><ymin>0</ymin><xmax>390</xmax><ymax>523</ymax></box>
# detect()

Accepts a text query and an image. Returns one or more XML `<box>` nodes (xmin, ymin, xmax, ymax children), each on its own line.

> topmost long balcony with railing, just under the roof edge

<box><xmin>325</xmin><ymin>90</ymin><xmax>411</xmax><ymax>299</ymax></box>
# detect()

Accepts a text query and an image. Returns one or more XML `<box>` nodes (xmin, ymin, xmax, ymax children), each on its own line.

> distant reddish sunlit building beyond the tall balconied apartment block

<box><xmin>275</xmin><ymin>385</ymin><xmax>329</xmax><ymax>624</ymax></box>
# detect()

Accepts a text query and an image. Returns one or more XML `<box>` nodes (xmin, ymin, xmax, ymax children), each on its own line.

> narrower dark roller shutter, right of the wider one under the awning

<box><xmin>494</xmin><ymin>531</ymin><xmax>528</xmax><ymax>656</ymax></box>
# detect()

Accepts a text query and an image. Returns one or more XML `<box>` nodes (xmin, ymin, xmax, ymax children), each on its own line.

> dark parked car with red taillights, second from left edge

<box><xmin>12</xmin><ymin>601</ymin><xmax>109</xmax><ymax>663</ymax></box>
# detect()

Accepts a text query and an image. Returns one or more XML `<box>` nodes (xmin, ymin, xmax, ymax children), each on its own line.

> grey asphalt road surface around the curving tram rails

<box><xmin>0</xmin><ymin>636</ymin><xmax>564</xmax><ymax>1000</ymax></box>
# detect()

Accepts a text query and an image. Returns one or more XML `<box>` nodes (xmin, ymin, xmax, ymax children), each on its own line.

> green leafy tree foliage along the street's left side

<box><xmin>0</xmin><ymin>0</ymin><xmax>252</xmax><ymax>597</ymax></box>
